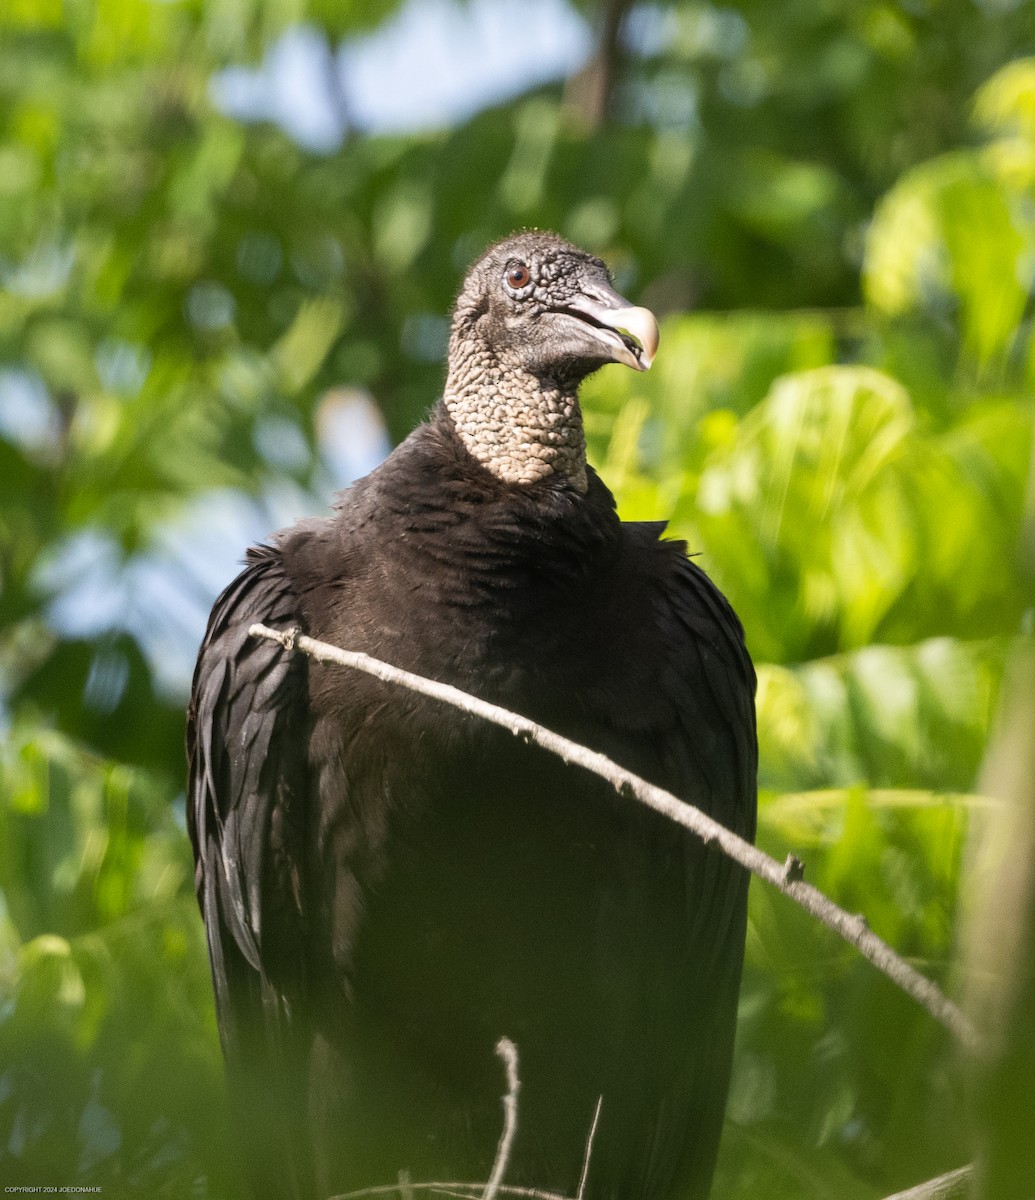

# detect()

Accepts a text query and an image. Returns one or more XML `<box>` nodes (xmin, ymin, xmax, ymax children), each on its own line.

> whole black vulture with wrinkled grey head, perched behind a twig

<box><xmin>189</xmin><ymin>232</ymin><xmax>756</xmax><ymax>1200</ymax></box>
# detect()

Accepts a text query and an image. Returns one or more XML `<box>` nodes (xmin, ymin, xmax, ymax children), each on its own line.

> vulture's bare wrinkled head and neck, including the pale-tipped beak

<box><xmin>443</xmin><ymin>230</ymin><xmax>658</xmax><ymax>492</ymax></box>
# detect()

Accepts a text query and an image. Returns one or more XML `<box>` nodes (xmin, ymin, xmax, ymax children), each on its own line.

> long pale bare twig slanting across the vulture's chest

<box><xmin>249</xmin><ymin>624</ymin><xmax>980</xmax><ymax>1052</ymax></box>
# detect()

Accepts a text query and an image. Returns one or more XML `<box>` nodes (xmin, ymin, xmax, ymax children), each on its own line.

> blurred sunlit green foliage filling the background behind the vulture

<box><xmin>0</xmin><ymin>0</ymin><xmax>1035</xmax><ymax>1200</ymax></box>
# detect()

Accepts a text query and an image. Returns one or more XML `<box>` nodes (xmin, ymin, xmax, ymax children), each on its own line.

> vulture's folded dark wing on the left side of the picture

<box><xmin>187</xmin><ymin>546</ymin><xmax>310</xmax><ymax>1198</ymax></box>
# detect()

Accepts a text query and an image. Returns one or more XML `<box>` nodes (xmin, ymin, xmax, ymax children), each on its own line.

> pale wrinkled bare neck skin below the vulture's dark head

<box><xmin>443</xmin><ymin>334</ymin><xmax>587</xmax><ymax>494</ymax></box>
